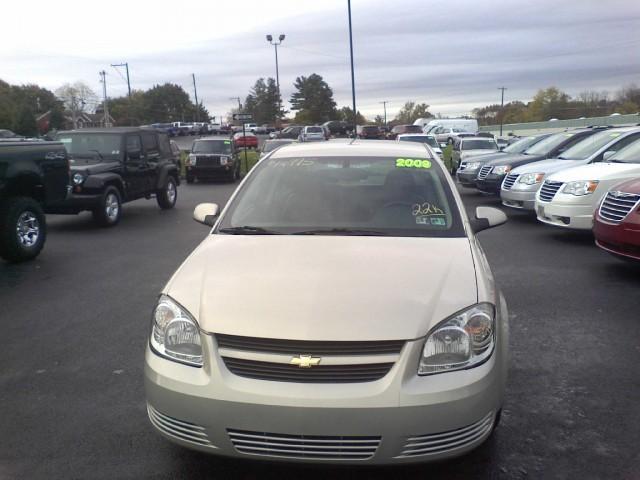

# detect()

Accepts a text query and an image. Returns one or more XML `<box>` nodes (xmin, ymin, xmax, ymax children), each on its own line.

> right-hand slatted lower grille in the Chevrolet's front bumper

<box><xmin>399</xmin><ymin>412</ymin><xmax>494</xmax><ymax>457</ymax></box>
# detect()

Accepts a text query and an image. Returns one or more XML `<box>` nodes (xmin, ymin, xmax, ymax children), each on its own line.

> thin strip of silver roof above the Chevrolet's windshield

<box><xmin>271</xmin><ymin>140</ymin><xmax>429</xmax><ymax>158</ymax></box>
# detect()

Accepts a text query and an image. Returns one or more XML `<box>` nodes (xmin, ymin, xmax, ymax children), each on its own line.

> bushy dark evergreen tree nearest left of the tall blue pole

<box><xmin>289</xmin><ymin>73</ymin><xmax>336</xmax><ymax>124</ymax></box>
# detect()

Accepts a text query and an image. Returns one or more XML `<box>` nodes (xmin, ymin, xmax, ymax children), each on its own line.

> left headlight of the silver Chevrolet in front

<box><xmin>150</xmin><ymin>295</ymin><xmax>202</xmax><ymax>367</ymax></box>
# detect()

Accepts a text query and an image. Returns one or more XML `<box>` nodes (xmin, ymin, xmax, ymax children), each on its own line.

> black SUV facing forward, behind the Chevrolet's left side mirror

<box><xmin>185</xmin><ymin>138</ymin><xmax>240</xmax><ymax>183</ymax></box>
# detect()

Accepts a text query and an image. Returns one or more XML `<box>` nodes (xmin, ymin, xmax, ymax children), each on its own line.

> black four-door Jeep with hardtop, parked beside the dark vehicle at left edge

<box><xmin>46</xmin><ymin>127</ymin><xmax>180</xmax><ymax>227</ymax></box>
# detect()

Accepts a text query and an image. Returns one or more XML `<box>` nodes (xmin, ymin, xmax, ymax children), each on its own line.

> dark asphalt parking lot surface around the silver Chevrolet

<box><xmin>0</xmin><ymin>170</ymin><xmax>640</xmax><ymax>479</ymax></box>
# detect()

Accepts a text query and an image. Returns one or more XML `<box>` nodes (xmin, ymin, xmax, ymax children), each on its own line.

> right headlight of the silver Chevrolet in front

<box><xmin>418</xmin><ymin>303</ymin><xmax>496</xmax><ymax>375</ymax></box>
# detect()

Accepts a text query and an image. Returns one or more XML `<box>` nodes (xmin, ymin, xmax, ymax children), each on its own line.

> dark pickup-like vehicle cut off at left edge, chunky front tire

<box><xmin>0</xmin><ymin>140</ymin><xmax>69</xmax><ymax>262</ymax></box>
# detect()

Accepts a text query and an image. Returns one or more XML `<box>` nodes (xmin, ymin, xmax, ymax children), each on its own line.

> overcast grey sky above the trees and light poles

<box><xmin>0</xmin><ymin>0</ymin><xmax>640</xmax><ymax>118</ymax></box>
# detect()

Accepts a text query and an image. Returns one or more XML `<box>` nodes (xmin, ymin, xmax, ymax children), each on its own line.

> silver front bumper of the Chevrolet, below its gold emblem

<box><xmin>145</xmin><ymin>311</ymin><xmax>508</xmax><ymax>464</ymax></box>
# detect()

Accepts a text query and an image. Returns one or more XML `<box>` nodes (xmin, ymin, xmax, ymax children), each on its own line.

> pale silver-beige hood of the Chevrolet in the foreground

<box><xmin>164</xmin><ymin>235</ymin><xmax>478</xmax><ymax>341</ymax></box>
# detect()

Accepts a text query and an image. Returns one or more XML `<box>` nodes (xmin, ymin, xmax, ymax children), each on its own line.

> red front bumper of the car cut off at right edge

<box><xmin>593</xmin><ymin>212</ymin><xmax>640</xmax><ymax>261</ymax></box>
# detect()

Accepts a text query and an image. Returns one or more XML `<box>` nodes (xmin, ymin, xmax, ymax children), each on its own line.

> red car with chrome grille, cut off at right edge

<box><xmin>593</xmin><ymin>178</ymin><xmax>640</xmax><ymax>261</ymax></box>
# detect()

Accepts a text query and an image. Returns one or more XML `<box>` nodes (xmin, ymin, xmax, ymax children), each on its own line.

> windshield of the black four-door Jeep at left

<box><xmin>58</xmin><ymin>133</ymin><xmax>122</xmax><ymax>162</ymax></box>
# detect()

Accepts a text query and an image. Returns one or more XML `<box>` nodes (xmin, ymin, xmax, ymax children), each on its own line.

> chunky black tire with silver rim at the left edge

<box><xmin>0</xmin><ymin>197</ymin><xmax>47</xmax><ymax>262</ymax></box>
